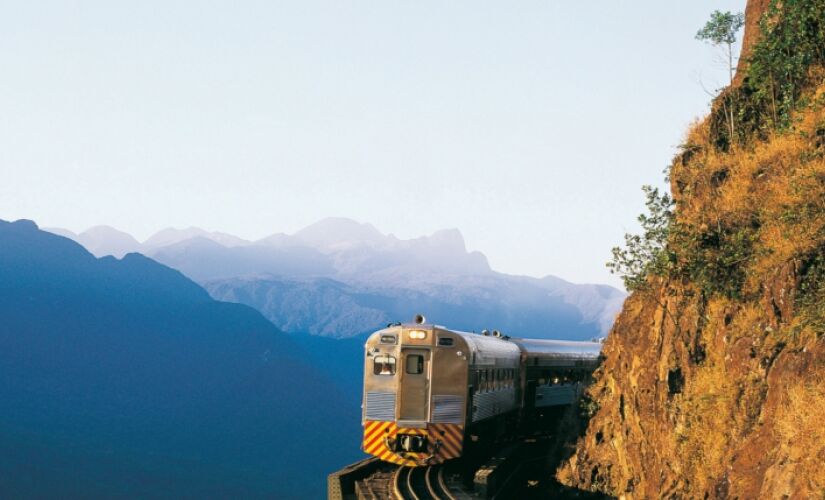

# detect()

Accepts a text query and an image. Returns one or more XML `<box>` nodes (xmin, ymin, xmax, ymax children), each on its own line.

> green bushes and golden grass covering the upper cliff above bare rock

<box><xmin>608</xmin><ymin>0</ymin><xmax>825</xmax><ymax>309</ymax></box>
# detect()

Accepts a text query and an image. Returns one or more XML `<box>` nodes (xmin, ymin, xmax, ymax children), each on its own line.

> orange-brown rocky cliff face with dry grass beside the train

<box><xmin>557</xmin><ymin>1</ymin><xmax>825</xmax><ymax>498</ymax></box>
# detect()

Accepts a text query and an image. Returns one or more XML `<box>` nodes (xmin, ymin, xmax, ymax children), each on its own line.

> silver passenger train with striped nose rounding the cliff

<box><xmin>361</xmin><ymin>315</ymin><xmax>602</xmax><ymax>467</ymax></box>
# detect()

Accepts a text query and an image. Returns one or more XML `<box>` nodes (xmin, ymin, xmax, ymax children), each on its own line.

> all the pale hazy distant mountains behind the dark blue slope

<box><xmin>47</xmin><ymin>218</ymin><xmax>625</xmax><ymax>339</ymax></box>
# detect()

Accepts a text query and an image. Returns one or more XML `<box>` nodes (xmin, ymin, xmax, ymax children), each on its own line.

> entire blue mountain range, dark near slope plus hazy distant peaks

<box><xmin>6</xmin><ymin>219</ymin><xmax>624</xmax><ymax>498</ymax></box>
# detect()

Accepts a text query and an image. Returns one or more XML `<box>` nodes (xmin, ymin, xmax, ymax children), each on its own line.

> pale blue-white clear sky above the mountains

<box><xmin>0</xmin><ymin>0</ymin><xmax>745</xmax><ymax>286</ymax></box>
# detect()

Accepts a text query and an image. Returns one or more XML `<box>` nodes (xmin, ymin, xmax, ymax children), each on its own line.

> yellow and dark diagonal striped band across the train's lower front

<box><xmin>362</xmin><ymin>420</ymin><xmax>464</xmax><ymax>467</ymax></box>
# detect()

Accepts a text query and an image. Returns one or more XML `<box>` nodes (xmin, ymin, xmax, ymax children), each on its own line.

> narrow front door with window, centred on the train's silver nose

<box><xmin>398</xmin><ymin>349</ymin><xmax>430</xmax><ymax>421</ymax></box>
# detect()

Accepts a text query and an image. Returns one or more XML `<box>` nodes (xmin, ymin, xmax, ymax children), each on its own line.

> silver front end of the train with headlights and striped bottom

<box><xmin>361</xmin><ymin>324</ymin><xmax>468</xmax><ymax>467</ymax></box>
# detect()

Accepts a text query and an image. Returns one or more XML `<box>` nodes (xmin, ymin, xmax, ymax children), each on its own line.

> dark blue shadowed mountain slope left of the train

<box><xmin>0</xmin><ymin>221</ymin><xmax>361</xmax><ymax>498</ymax></box>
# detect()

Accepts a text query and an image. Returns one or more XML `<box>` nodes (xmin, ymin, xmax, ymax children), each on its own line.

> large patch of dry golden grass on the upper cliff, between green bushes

<box><xmin>672</xmin><ymin>81</ymin><xmax>825</xmax><ymax>293</ymax></box>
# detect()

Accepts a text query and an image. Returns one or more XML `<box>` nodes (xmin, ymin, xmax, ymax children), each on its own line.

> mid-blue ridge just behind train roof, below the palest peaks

<box><xmin>204</xmin><ymin>276</ymin><xmax>623</xmax><ymax>339</ymax></box>
